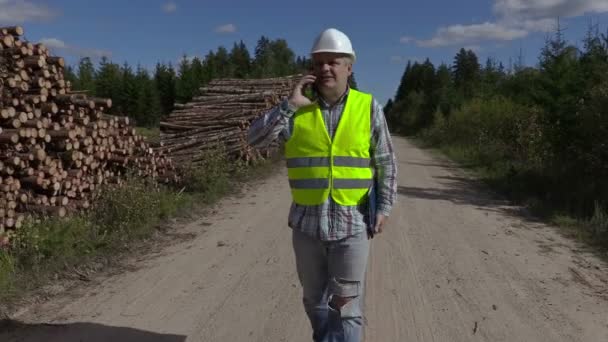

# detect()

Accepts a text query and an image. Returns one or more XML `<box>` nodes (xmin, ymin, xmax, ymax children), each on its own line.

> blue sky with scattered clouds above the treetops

<box><xmin>0</xmin><ymin>0</ymin><xmax>608</xmax><ymax>103</ymax></box>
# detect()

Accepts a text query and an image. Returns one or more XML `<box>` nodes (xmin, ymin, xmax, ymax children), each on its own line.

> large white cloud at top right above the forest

<box><xmin>416</xmin><ymin>0</ymin><xmax>608</xmax><ymax>47</ymax></box>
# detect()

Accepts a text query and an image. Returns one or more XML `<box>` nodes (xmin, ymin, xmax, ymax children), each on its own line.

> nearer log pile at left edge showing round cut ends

<box><xmin>0</xmin><ymin>26</ymin><xmax>176</xmax><ymax>237</ymax></box>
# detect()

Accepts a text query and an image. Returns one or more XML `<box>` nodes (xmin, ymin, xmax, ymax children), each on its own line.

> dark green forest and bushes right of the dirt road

<box><xmin>385</xmin><ymin>24</ymin><xmax>608</xmax><ymax>242</ymax></box>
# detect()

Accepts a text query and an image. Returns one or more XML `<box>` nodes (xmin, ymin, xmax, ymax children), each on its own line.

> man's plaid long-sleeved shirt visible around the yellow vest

<box><xmin>248</xmin><ymin>90</ymin><xmax>397</xmax><ymax>241</ymax></box>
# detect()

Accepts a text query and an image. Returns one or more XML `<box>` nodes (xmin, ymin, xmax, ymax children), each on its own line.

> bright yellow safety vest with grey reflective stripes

<box><xmin>285</xmin><ymin>89</ymin><xmax>373</xmax><ymax>205</ymax></box>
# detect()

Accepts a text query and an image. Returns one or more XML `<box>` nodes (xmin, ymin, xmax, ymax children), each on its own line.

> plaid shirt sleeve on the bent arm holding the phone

<box><xmin>247</xmin><ymin>100</ymin><xmax>295</xmax><ymax>148</ymax></box>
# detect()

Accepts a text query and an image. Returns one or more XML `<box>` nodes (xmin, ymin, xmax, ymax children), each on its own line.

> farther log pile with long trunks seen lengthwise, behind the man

<box><xmin>155</xmin><ymin>75</ymin><xmax>301</xmax><ymax>165</ymax></box>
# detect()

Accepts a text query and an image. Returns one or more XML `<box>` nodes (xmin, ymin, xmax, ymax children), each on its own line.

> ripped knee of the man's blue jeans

<box><xmin>329</xmin><ymin>278</ymin><xmax>361</xmax><ymax>317</ymax></box>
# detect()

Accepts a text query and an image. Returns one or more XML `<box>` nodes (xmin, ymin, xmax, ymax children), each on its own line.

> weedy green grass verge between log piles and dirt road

<box><xmin>0</xmin><ymin>146</ymin><xmax>284</xmax><ymax>312</ymax></box>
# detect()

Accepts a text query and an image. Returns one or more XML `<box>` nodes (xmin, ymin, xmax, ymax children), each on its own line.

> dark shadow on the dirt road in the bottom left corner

<box><xmin>0</xmin><ymin>319</ymin><xmax>186</xmax><ymax>342</ymax></box>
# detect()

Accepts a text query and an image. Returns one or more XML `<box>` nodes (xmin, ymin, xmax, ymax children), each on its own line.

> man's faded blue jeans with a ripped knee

<box><xmin>292</xmin><ymin>230</ymin><xmax>369</xmax><ymax>342</ymax></box>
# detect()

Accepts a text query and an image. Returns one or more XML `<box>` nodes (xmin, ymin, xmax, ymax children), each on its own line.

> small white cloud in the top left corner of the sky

<box><xmin>0</xmin><ymin>0</ymin><xmax>57</xmax><ymax>24</ymax></box>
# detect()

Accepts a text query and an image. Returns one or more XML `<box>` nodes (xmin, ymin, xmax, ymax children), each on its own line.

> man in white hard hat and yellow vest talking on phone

<box><xmin>249</xmin><ymin>28</ymin><xmax>397</xmax><ymax>342</ymax></box>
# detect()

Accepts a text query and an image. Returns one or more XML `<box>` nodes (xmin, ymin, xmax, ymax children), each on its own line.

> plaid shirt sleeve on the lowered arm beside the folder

<box><xmin>372</xmin><ymin>99</ymin><xmax>397</xmax><ymax>216</ymax></box>
